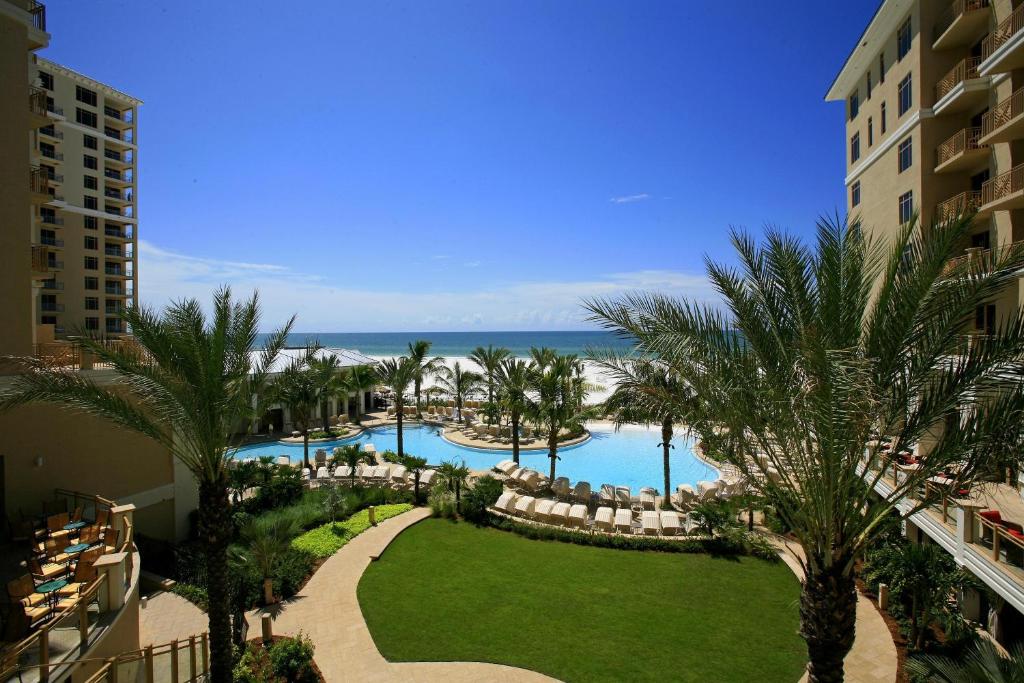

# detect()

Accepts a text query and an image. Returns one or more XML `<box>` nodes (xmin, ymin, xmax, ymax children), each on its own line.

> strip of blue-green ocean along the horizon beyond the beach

<box><xmin>260</xmin><ymin>331</ymin><xmax>632</xmax><ymax>358</ymax></box>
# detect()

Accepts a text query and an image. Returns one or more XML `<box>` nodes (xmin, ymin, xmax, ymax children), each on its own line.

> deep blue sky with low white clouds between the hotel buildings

<box><xmin>42</xmin><ymin>0</ymin><xmax>877</xmax><ymax>331</ymax></box>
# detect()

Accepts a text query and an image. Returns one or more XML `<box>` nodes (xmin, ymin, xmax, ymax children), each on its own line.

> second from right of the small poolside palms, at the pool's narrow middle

<box><xmin>528</xmin><ymin>356</ymin><xmax>587</xmax><ymax>481</ymax></box>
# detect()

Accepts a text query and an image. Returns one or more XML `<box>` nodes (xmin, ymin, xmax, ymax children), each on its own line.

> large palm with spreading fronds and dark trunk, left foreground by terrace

<box><xmin>0</xmin><ymin>287</ymin><xmax>294</xmax><ymax>683</ymax></box>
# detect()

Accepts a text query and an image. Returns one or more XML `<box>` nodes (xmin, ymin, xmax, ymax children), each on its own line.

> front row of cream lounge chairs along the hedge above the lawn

<box><xmin>495</xmin><ymin>490</ymin><xmax>684</xmax><ymax>536</ymax></box>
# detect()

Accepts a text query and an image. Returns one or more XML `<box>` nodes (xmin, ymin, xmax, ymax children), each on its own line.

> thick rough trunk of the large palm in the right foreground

<box><xmin>800</xmin><ymin>558</ymin><xmax>857</xmax><ymax>683</ymax></box>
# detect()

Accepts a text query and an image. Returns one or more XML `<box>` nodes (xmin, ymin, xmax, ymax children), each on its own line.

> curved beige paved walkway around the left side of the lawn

<box><xmin>247</xmin><ymin>508</ymin><xmax>555</xmax><ymax>683</ymax></box>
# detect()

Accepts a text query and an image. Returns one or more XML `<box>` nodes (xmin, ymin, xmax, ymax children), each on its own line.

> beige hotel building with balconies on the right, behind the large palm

<box><xmin>825</xmin><ymin>0</ymin><xmax>1024</xmax><ymax>646</ymax></box>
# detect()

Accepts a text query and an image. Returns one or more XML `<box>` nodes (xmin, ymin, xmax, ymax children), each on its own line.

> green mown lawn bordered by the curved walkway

<box><xmin>358</xmin><ymin>519</ymin><xmax>806</xmax><ymax>683</ymax></box>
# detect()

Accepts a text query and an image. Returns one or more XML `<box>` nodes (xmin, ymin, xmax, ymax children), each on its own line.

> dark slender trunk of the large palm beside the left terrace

<box><xmin>199</xmin><ymin>479</ymin><xmax>232</xmax><ymax>683</ymax></box>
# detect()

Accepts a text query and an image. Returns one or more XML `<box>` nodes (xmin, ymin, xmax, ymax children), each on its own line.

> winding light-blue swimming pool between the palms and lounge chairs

<box><xmin>238</xmin><ymin>425</ymin><xmax>718</xmax><ymax>492</ymax></box>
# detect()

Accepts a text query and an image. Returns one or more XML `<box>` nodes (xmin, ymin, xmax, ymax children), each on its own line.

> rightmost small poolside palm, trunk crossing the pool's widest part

<box><xmin>592</xmin><ymin>358</ymin><xmax>692</xmax><ymax>510</ymax></box>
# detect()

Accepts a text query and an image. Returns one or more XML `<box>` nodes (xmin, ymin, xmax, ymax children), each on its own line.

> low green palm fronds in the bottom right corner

<box><xmin>906</xmin><ymin>638</ymin><xmax>1024</xmax><ymax>683</ymax></box>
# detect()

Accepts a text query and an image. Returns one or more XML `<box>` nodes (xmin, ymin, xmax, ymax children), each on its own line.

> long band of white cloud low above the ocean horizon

<box><xmin>139</xmin><ymin>241</ymin><xmax>716</xmax><ymax>332</ymax></box>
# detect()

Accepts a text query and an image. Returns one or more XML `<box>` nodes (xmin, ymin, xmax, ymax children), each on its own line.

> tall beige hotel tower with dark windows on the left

<box><xmin>0</xmin><ymin>0</ymin><xmax>141</xmax><ymax>355</ymax></box>
